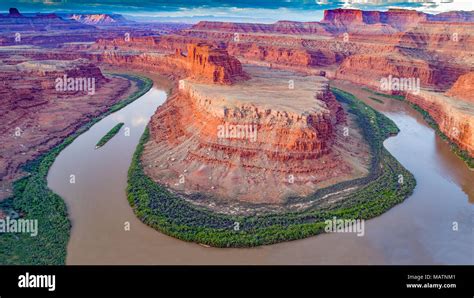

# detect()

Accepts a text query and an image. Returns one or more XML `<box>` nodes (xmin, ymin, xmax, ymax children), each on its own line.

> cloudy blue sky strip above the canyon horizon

<box><xmin>0</xmin><ymin>0</ymin><xmax>474</xmax><ymax>23</ymax></box>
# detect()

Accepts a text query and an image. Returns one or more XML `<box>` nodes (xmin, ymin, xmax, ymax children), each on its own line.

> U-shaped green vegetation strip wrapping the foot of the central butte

<box><xmin>127</xmin><ymin>89</ymin><xmax>416</xmax><ymax>247</ymax></box>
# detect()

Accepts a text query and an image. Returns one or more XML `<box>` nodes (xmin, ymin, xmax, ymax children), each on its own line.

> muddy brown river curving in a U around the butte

<box><xmin>48</xmin><ymin>84</ymin><xmax>474</xmax><ymax>264</ymax></box>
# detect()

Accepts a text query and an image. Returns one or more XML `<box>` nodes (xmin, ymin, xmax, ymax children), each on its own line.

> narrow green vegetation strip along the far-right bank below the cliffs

<box><xmin>362</xmin><ymin>88</ymin><xmax>474</xmax><ymax>169</ymax></box>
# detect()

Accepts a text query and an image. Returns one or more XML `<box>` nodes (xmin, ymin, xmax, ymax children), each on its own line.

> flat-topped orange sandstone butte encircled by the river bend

<box><xmin>142</xmin><ymin>66</ymin><xmax>369</xmax><ymax>205</ymax></box>
